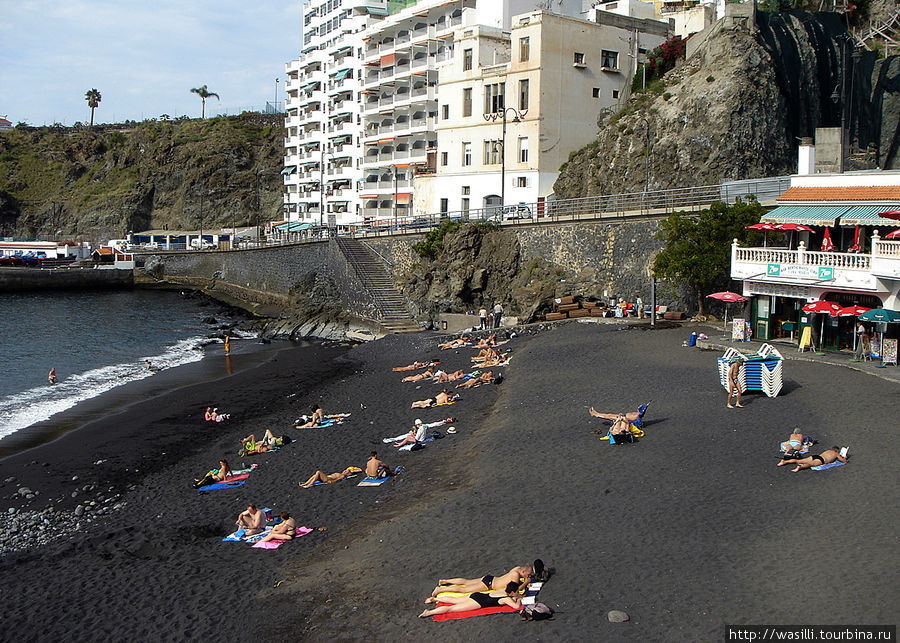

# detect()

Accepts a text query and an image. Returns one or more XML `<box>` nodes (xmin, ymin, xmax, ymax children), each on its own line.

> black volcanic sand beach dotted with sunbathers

<box><xmin>0</xmin><ymin>323</ymin><xmax>900</xmax><ymax>641</ymax></box>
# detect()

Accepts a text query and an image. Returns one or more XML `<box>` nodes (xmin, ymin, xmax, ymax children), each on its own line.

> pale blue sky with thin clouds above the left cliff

<box><xmin>0</xmin><ymin>0</ymin><xmax>303</xmax><ymax>125</ymax></box>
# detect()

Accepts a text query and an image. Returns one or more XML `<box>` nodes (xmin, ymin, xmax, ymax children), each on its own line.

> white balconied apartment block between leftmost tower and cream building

<box><xmin>359</xmin><ymin>0</ymin><xmax>583</xmax><ymax>222</ymax></box>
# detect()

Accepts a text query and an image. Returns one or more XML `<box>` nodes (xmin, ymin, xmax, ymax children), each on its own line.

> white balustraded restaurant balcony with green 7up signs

<box><xmin>731</xmin><ymin>237</ymin><xmax>900</xmax><ymax>292</ymax></box>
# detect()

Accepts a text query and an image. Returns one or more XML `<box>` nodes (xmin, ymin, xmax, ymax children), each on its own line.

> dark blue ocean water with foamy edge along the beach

<box><xmin>0</xmin><ymin>291</ymin><xmax>217</xmax><ymax>438</ymax></box>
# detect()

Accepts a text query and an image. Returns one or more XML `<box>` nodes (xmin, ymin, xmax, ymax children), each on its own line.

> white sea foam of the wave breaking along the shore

<box><xmin>0</xmin><ymin>337</ymin><xmax>205</xmax><ymax>438</ymax></box>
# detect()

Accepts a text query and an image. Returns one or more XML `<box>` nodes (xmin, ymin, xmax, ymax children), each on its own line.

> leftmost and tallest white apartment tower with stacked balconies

<box><xmin>282</xmin><ymin>0</ymin><xmax>389</xmax><ymax>226</ymax></box>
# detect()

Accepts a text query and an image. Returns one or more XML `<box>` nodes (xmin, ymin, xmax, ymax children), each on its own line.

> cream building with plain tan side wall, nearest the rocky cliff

<box><xmin>414</xmin><ymin>11</ymin><xmax>669</xmax><ymax>216</ymax></box>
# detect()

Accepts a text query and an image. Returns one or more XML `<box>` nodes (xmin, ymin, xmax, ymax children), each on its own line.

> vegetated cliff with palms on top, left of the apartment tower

<box><xmin>0</xmin><ymin>114</ymin><xmax>283</xmax><ymax>240</ymax></box>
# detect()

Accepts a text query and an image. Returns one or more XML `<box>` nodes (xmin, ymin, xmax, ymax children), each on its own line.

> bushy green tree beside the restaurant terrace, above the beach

<box><xmin>653</xmin><ymin>196</ymin><xmax>766</xmax><ymax>315</ymax></box>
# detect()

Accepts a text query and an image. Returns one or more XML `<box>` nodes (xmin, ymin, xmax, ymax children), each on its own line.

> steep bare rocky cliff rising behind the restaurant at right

<box><xmin>555</xmin><ymin>12</ymin><xmax>900</xmax><ymax>198</ymax></box>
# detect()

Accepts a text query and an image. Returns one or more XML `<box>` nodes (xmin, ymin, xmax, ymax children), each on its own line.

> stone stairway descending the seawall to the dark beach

<box><xmin>336</xmin><ymin>237</ymin><xmax>422</xmax><ymax>333</ymax></box>
